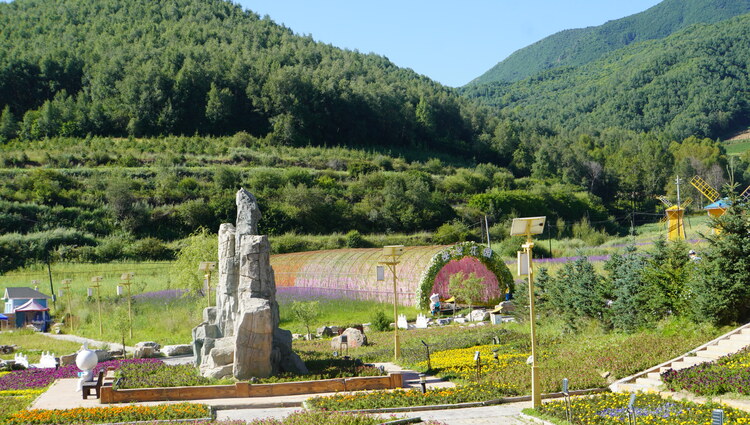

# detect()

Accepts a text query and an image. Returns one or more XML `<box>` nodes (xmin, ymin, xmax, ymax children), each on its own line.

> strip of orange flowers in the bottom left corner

<box><xmin>5</xmin><ymin>403</ymin><xmax>211</xmax><ymax>425</ymax></box>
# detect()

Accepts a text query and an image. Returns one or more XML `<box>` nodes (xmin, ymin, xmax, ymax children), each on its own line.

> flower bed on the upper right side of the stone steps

<box><xmin>661</xmin><ymin>347</ymin><xmax>750</xmax><ymax>395</ymax></box>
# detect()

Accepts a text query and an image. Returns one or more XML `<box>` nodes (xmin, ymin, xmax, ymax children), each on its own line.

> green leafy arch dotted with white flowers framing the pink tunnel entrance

<box><xmin>415</xmin><ymin>242</ymin><xmax>513</xmax><ymax>309</ymax></box>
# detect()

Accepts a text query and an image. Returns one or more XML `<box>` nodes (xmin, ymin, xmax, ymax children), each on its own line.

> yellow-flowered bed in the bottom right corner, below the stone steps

<box><xmin>534</xmin><ymin>393</ymin><xmax>750</xmax><ymax>425</ymax></box>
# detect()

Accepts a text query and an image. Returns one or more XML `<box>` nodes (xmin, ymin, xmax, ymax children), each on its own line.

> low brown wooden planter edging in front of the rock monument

<box><xmin>100</xmin><ymin>373</ymin><xmax>403</xmax><ymax>404</ymax></box>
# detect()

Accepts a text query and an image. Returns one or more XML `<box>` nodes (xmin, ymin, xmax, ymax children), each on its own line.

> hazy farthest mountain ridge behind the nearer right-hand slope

<box><xmin>468</xmin><ymin>0</ymin><xmax>750</xmax><ymax>86</ymax></box>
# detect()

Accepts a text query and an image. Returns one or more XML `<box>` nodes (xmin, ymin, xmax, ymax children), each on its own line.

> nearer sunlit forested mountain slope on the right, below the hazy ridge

<box><xmin>466</xmin><ymin>15</ymin><xmax>750</xmax><ymax>140</ymax></box>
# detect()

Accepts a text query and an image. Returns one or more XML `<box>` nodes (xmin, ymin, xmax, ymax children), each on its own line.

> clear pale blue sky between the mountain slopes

<box><xmin>239</xmin><ymin>0</ymin><xmax>660</xmax><ymax>87</ymax></box>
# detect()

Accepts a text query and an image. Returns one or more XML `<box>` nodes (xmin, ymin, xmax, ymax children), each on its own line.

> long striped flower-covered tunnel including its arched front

<box><xmin>271</xmin><ymin>243</ymin><xmax>512</xmax><ymax>307</ymax></box>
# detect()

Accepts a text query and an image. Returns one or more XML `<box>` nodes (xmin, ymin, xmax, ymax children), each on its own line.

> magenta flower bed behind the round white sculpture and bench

<box><xmin>0</xmin><ymin>359</ymin><xmax>162</xmax><ymax>391</ymax></box>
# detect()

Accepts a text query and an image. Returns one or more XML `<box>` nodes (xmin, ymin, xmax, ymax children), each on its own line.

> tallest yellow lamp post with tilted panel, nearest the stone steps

<box><xmin>510</xmin><ymin>217</ymin><xmax>546</xmax><ymax>408</ymax></box>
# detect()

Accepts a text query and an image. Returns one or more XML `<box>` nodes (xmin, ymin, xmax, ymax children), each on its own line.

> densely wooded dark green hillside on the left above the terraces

<box><xmin>0</xmin><ymin>0</ymin><xmax>500</xmax><ymax>157</ymax></box>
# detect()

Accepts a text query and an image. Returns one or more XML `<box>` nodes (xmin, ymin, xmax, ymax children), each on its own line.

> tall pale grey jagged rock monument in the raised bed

<box><xmin>193</xmin><ymin>189</ymin><xmax>308</xmax><ymax>379</ymax></box>
